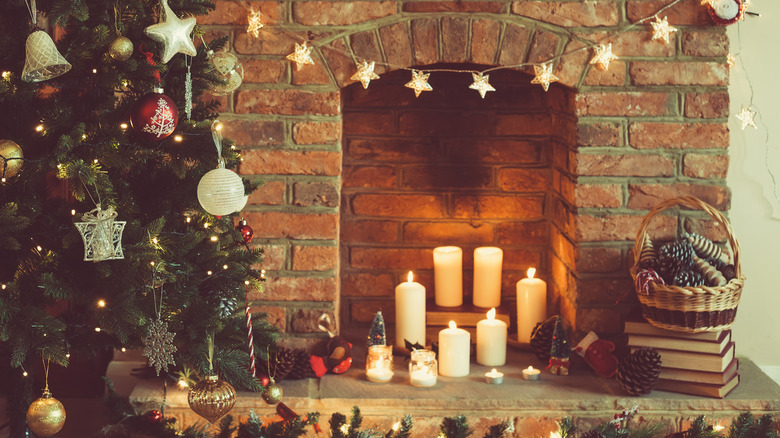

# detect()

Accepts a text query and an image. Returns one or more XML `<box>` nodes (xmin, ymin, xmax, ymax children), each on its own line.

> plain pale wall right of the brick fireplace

<box><xmin>728</xmin><ymin>0</ymin><xmax>780</xmax><ymax>372</ymax></box>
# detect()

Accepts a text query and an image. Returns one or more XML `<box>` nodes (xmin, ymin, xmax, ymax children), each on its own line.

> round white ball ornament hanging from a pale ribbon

<box><xmin>198</xmin><ymin>120</ymin><xmax>249</xmax><ymax>216</ymax></box>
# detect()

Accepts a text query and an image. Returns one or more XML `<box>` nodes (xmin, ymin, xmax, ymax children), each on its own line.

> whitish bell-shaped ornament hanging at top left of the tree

<box><xmin>22</xmin><ymin>0</ymin><xmax>71</xmax><ymax>82</ymax></box>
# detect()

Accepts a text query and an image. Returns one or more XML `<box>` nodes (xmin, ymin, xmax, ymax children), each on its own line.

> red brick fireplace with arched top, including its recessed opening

<box><xmin>206</xmin><ymin>0</ymin><xmax>730</xmax><ymax>339</ymax></box>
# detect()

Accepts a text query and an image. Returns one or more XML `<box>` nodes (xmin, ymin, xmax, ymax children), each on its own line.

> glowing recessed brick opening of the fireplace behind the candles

<box><xmin>340</xmin><ymin>64</ymin><xmax>577</xmax><ymax>332</ymax></box>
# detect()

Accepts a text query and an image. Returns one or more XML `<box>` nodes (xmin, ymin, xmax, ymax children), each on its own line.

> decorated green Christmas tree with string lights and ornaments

<box><xmin>0</xmin><ymin>0</ymin><xmax>276</xmax><ymax>436</ymax></box>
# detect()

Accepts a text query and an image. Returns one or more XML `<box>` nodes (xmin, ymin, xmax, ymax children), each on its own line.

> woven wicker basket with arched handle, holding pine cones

<box><xmin>631</xmin><ymin>196</ymin><xmax>745</xmax><ymax>333</ymax></box>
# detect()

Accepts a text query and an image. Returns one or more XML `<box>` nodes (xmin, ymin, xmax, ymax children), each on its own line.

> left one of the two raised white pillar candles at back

<box><xmin>433</xmin><ymin>246</ymin><xmax>463</xmax><ymax>307</ymax></box>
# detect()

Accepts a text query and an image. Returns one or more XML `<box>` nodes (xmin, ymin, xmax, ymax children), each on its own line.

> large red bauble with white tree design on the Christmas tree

<box><xmin>130</xmin><ymin>88</ymin><xmax>179</xmax><ymax>140</ymax></box>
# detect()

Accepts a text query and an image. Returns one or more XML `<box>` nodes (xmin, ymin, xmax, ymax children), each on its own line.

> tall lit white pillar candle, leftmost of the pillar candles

<box><xmin>395</xmin><ymin>271</ymin><xmax>425</xmax><ymax>348</ymax></box>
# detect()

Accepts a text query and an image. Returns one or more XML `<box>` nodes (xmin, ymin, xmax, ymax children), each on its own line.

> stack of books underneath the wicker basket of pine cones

<box><xmin>625</xmin><ymin>321</ymin><xmax>739</xmax><ymax>398</ymax></box>
